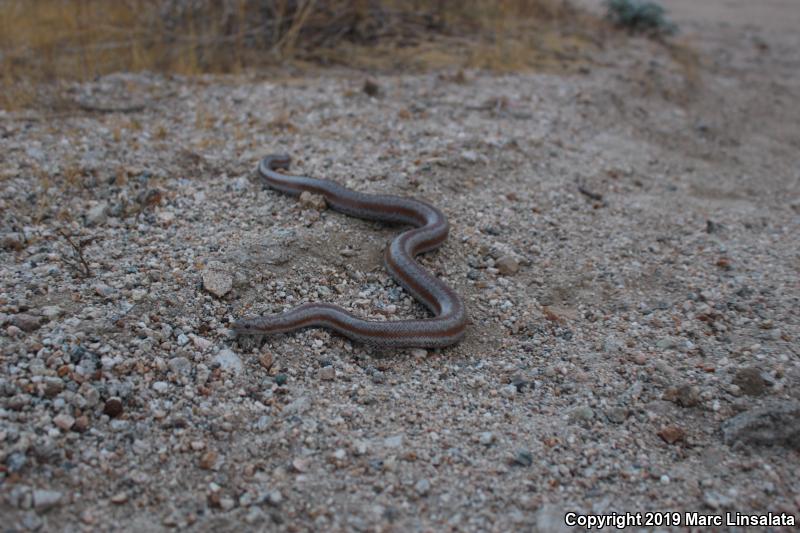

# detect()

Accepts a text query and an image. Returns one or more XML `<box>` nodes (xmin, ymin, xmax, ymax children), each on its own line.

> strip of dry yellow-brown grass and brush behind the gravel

<box><xmin>0</xmin><ymin>0</ymin><xmax>591</xmax><ymax>107</ymax></box>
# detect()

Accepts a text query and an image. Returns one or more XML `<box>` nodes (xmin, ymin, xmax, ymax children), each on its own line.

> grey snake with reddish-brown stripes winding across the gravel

<box><xmin>232</xmin><ymin>154</ymin><xmax>468</xmax><ymax>348</ymax></box>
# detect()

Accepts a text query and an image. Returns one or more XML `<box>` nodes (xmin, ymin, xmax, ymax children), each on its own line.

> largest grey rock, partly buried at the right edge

<box><xmin>722</xmin><ymin>400</ymin><xmax>800</xmax><ymax>450</ymax></box>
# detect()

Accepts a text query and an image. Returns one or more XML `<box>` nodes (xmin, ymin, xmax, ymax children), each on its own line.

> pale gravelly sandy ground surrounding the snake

<box><xmin>0</xmin><ymin>0</ymin><xmax>800</xmax><ymax>531</ymax></box>
